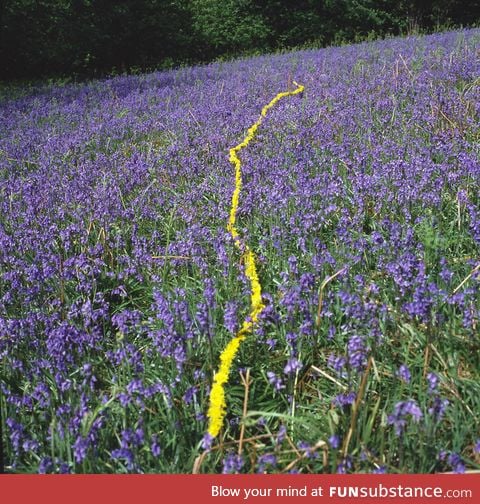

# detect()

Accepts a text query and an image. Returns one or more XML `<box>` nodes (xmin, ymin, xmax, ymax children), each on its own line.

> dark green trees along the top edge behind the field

<box><xmin>0</xmin><ymin>0</ymin><xmax>480</xmax><ymax>79</ymax></box>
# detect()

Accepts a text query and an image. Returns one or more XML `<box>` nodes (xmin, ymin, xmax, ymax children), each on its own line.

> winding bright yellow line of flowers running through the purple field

<box><xmin>207</xmin><ymin>82</ymin><xmax>305</xmax><ymax>437</ymax></box>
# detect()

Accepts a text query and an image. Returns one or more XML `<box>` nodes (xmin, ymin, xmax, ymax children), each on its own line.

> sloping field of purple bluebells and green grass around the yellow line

<box><xmin>0</xmin><ymin>29</ymin><xmax>480</xmax><ymax>473</ymax></box>
